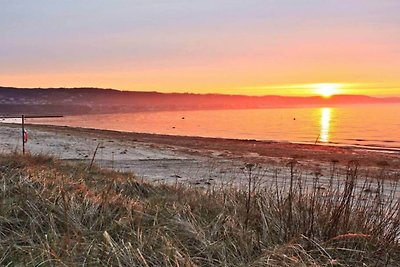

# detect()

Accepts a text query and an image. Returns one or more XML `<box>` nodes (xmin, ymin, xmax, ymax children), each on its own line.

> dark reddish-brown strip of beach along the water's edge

<box><xmin>0</xmin><ymin>123</ymin><xmax>400</xmax><ymax>169</ymax></box>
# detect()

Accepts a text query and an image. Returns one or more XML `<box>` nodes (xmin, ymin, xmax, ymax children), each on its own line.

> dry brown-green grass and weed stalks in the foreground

<box><xmin>0</xmin><ymin>154</ymin><xmax>400</xmax><ymax>266</ymax></box>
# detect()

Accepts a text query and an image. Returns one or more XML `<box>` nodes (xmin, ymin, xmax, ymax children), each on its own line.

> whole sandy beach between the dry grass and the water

<box><xmin>0</xmin><ymin>124</ymin><xmax>400</xmax><ymax>191</ymax></box>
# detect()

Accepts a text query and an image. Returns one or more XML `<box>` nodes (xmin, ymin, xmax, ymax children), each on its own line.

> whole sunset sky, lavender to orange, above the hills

<box><xmin>0</xmin><ymin>0</ymin><xmax>400</xmax><ymax>96</ymax></box>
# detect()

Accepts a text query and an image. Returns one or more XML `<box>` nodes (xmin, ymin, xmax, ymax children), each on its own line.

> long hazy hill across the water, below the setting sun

<box><xmin>0</xmin><ymin>87</ymin><xmax>400</xmax><ymax>115</ymax></box>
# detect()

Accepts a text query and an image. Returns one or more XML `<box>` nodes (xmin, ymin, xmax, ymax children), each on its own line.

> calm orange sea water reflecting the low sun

<box><xmin>28</xmin><ymin>105</ymin><xmax>400</xmax><ymax>149</ymax></box>
